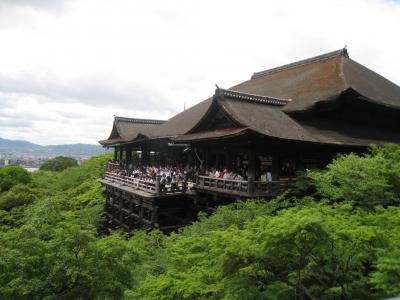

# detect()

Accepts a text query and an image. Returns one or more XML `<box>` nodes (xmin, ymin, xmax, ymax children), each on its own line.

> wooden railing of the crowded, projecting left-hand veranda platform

<box><xmin>103</xmin><ymin>172</ymin><xmax>187</xmax><ymax>195</ymax></box>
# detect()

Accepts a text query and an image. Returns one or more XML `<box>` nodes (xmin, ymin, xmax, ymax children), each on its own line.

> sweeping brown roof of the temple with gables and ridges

<box><xmin>100</xmin><ymin>49</ymin><xmax>400</xmax><ymax>148</ymax></box>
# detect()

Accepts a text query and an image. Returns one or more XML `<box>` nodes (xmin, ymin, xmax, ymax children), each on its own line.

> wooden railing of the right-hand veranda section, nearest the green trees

<box><xmin>195</xmin><ymin>176</ymin><xmax>293</xmax><ymax>197</ymax></box>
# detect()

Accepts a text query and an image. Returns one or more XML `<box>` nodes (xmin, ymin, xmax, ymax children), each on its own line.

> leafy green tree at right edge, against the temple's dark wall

<box><xmin>307</xmin><ymin>144</ymin><xmax>400</xmax><ymax>208</ymax></box>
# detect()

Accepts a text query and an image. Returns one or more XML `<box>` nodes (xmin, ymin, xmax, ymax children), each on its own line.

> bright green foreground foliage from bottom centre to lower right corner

<box><xmin>131</xmin><ymin>204</ymin><xmax>400</xmax><ymax>299</ymax></box>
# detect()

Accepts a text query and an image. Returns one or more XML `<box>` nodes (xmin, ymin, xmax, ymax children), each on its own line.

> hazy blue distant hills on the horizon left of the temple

<box><xmin>0</xmin><ymin>138</ymin><xmax>108</xmax><ymax>157</ymax></box>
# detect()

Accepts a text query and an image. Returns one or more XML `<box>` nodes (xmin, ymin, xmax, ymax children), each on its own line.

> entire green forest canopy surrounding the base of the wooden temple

<box><xmin>0</xmin><ymin>145</ymin><xmax>400</xmax><ymax>299</ymax></box>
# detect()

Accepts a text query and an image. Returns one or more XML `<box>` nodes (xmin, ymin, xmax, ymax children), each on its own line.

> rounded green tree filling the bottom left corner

<box><xmin>0</xmin><ymin>222</ymin><xmax>136</xmax><ymax>299</ymax></box>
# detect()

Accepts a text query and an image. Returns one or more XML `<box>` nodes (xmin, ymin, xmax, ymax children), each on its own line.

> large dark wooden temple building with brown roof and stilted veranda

<box><xmin>100</xmin><ymin>49</ymin><xmax>400</xmax><ymax>231</ymax></box>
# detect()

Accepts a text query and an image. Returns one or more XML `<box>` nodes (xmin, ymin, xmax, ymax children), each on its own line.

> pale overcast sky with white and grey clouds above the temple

<box><xmin>0</xmin><ymin>0</ymin><xmax>400</xmax><ymax>145</ymax></box>
